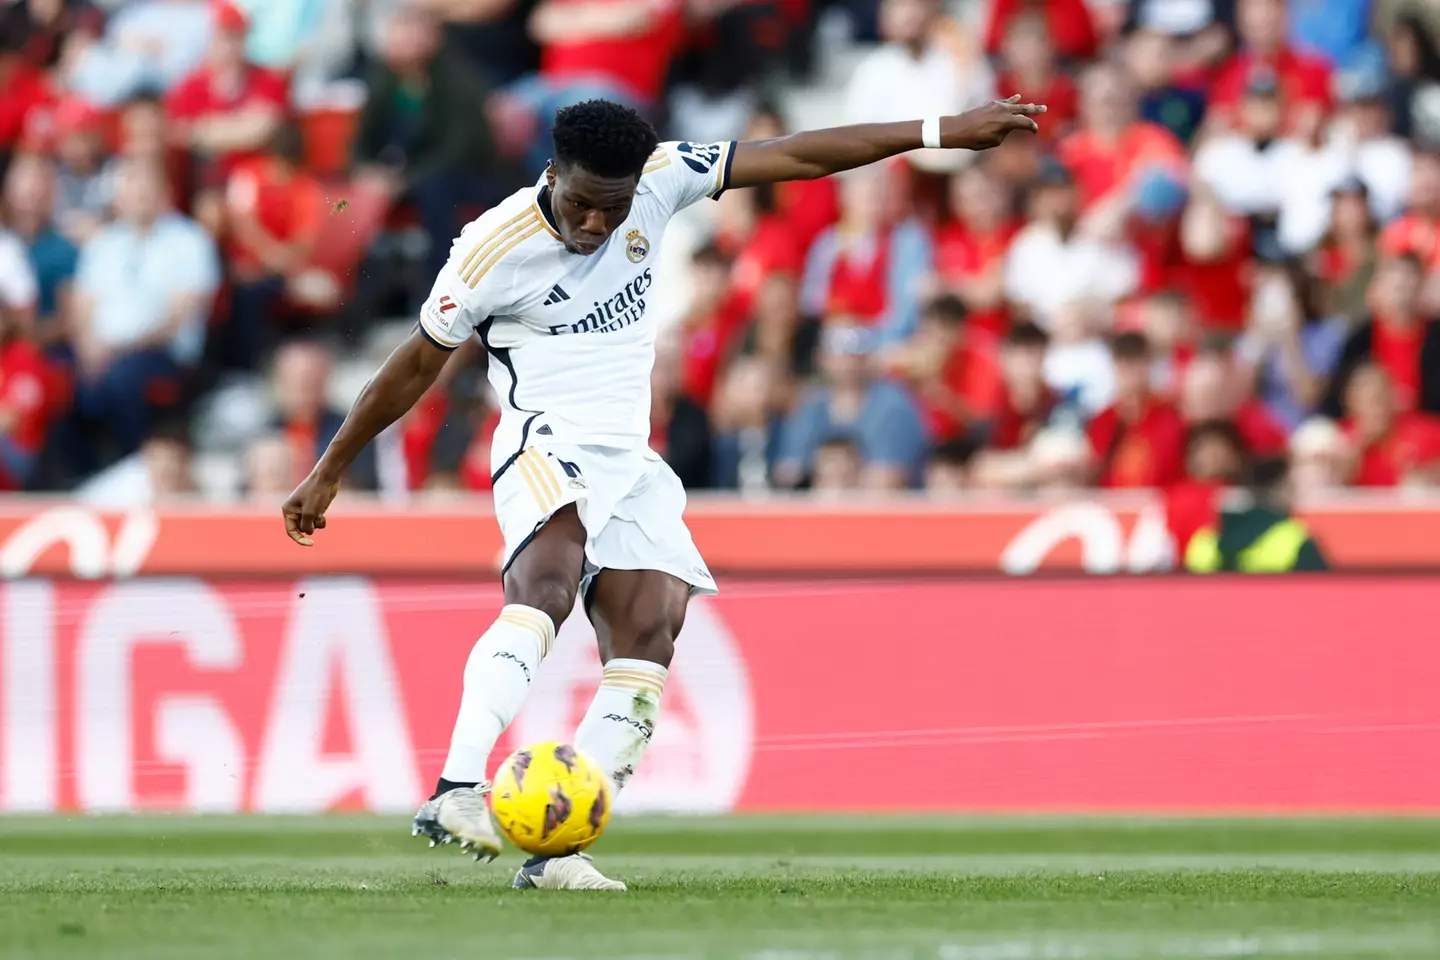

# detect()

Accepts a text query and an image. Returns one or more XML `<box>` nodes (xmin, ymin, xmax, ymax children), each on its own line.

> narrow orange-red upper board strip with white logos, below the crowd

<box><xmin>0</xmin><ymin>494</ymin><xmax>1440</xmax><ymax>579</ymax></box>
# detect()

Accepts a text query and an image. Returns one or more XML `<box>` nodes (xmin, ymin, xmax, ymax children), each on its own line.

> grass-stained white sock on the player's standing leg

<box><xmin>575</xmin><ymin>659</ymin><xmax>670</xmax><ymax>790</ymax></box>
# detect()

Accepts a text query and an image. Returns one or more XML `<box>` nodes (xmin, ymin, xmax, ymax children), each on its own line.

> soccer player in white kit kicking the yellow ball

<box><xmin>282</xmin><ymin>96</ymin><xmax>1045</xmax><ymax>889</ymax></box>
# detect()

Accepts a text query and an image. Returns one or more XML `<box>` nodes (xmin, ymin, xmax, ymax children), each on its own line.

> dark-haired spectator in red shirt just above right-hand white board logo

<box><xmin>1086</xmin><ymin>332</ymin><xmax>1185</xmax><ymax>488</ymax></box>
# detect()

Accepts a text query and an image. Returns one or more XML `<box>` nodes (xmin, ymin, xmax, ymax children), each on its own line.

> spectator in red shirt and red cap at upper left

<box><xmin>166</xmin><ymin>1</ymin><xmax>287</xmax><ymax>186</ymax></box>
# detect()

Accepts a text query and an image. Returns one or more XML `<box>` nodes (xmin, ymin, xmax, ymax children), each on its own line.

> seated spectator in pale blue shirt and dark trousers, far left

<box><xmin>75</xmin><ymin>160</ymin><xmax>220</xmax><ymax>456</ymax></box>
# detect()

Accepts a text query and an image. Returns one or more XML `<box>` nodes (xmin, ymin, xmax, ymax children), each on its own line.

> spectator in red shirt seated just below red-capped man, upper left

<box><xmin>225</xmin><ymin>125</ymin><xmax>340</xmax><ymax>368</ymax></box>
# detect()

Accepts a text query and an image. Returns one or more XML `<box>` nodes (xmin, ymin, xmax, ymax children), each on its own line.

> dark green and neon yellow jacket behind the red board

<box><xmin>1185</xmin><ymin>507</ymin><xmax>1329</xmax><ymax>573</ymax></box>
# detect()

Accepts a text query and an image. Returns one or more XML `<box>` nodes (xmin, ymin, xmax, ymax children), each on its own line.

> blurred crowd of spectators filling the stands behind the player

<box><xmin>0</xmin><ymin>0</ymin><xmax>1440</xmax><ymax>515</ymax></box>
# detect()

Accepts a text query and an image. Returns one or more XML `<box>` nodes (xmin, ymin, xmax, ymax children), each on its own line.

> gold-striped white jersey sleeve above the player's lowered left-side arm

<box><xmin>420</xmin><ymin>207</ymin><xmax>541</xmax><ymax>350</ymax></box>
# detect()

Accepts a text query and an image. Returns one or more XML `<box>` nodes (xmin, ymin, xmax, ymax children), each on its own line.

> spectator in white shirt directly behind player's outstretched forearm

<box><xmin>845</xmin><ymin>0</ymin><xmax>995</xmax><ymax>171</ymax></box>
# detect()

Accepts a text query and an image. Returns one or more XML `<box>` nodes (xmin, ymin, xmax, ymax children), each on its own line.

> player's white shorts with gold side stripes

<box><xmin>494</xmin><ymin>443</ymin><xmax>717</xmax><ymax>596</ymax></box>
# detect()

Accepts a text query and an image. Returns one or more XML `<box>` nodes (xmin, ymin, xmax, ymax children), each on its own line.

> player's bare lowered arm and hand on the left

<box><xmin>281</xmin><ymin>328</ymin><xmax>452</xmax><ymax>547</ymax></box>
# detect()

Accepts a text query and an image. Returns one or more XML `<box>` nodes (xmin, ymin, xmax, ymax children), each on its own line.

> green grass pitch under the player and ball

<box><xmin>0</xmin><ymin>816</ymin><xmax>1440</xmax><ymax>960</ymax></box>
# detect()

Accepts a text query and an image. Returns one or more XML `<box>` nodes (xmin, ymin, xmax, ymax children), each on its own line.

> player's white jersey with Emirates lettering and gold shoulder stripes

<box><xmin>420</xmin><ymin>142</ymin><xmax>734</xmax><ymax>474</ymax></box>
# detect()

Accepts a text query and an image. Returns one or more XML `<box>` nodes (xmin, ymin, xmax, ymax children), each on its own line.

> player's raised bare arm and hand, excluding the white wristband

<box><xmin>727</xmin><ymin>95</ymin><xmax>1045</xmax><ymax>187</ymax></box>
